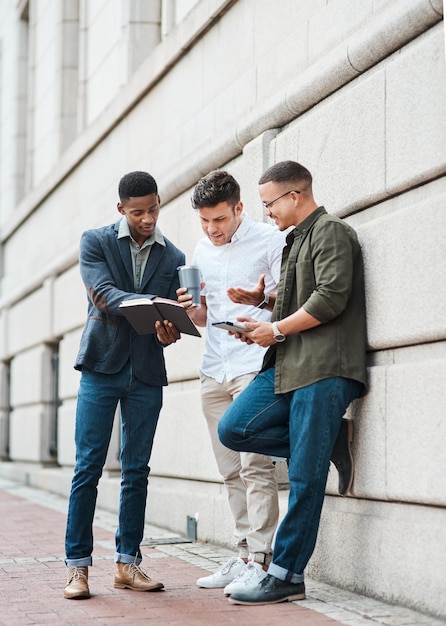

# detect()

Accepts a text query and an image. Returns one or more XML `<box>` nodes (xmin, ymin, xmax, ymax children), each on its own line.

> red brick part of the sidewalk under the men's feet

<box><xmin>0</xmin><ymin>488</ymin><xmax>339</xmax><ymax>626</ymax></box>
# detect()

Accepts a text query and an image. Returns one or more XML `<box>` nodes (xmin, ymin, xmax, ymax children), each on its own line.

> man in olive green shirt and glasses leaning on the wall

<box><xmin>219</xmin><ymin>161</ymin><xmax>367</xmax><ymax>604</ymax></box>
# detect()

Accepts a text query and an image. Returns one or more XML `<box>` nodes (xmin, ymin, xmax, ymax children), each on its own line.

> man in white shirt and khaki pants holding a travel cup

<box><xmin>177</xmin><ymin>170</ymin><xmax>286</xmax><ymax>595</ymax></box>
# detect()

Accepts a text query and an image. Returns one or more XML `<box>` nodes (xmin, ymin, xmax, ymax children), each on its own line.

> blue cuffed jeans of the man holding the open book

<box><xmin>65</xmin><ymin>363</ymin><xmax>162</xmax><ymax>567</ymax></box>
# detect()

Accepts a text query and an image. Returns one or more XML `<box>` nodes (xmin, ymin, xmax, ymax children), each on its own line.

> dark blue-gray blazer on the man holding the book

<box><xmin>74</xmin><ymin>220</ymin><xmax>185</xmax><ymax>387</ymax></box>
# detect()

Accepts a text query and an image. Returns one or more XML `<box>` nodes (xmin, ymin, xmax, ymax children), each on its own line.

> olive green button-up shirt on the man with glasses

<box><xmin>263</xmin><ymin>207</ymin><xmax>367</xmax><ymax>393</ymax></box>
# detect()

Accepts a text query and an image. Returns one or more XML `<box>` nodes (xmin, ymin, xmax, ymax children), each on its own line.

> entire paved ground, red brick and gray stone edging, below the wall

<box><xmin>0</xmin><ymin>478</ymin><xmax>446</xmax><ymax>626</ymax></box>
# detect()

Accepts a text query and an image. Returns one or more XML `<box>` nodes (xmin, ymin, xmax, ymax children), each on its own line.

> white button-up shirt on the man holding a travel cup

<box><xmin>192</xmin><ymin>213</ymin><xmax>286</xmax><ymax>383</ymax></box>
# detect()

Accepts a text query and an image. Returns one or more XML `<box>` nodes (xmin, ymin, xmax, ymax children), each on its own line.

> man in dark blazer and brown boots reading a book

<box><xmin>64</xmin><ymin>172</ymin><xmax>185</xmax><ymax>599</ymax></box>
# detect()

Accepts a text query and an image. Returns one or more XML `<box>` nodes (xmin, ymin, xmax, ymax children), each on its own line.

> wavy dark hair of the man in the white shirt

<box><xmin>191</xmin><ymin>170</ymin><xmax>240</xmax><ymax>209</ymax></box>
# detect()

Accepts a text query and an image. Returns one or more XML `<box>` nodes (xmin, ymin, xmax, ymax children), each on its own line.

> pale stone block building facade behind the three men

<box><xmin>0</xmin><ymin>0</ymin><xmax>446</xmax><ymax>617</ymax></box>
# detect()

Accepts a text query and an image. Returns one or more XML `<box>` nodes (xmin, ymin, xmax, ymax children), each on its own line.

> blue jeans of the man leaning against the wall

<box><xmin>218</xmin><ymin>367</ymin><xmax>362</xmax><ymax>583</ymax></box>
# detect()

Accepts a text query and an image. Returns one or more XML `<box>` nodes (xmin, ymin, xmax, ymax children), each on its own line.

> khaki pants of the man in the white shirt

<box><xmin>200</xmin><ymin>373</ymin><xmax>279</xmax><ymax>565</ymax></box>
